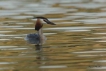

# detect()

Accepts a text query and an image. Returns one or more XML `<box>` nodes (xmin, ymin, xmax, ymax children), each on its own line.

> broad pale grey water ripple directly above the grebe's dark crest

<box><xmin>24</xmin><ymin>5</ymin><xmax>63</xmax><ymax>15</ymax></box>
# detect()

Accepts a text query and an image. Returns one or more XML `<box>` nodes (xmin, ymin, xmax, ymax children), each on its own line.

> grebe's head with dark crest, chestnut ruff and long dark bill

<box><xmin>33</xmin><ymin>17</ymin><xmax>56</xmax><ymax>31</ymax></box>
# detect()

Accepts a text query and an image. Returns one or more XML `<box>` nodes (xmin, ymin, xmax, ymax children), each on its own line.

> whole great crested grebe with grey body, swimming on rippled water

<box><xmin>25</xmin><ymin>17</ymin><xmax>55</xmax><ymax>45</ymax></box>
